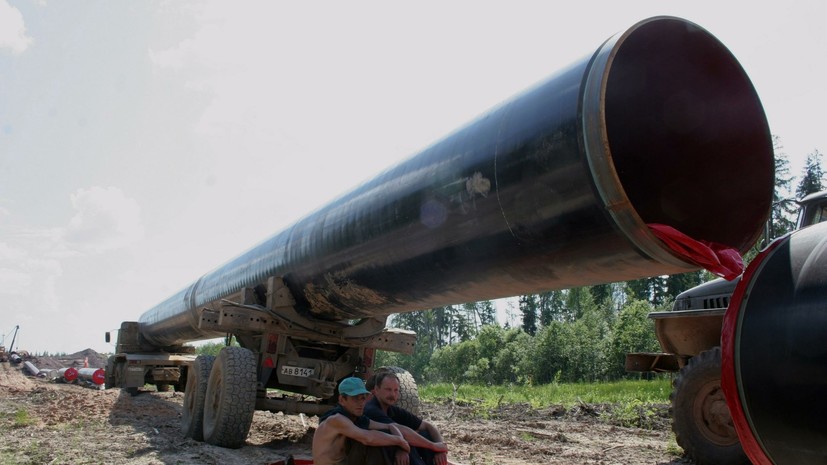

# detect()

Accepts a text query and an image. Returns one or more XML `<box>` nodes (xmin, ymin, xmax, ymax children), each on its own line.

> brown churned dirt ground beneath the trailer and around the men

<box><xmin>0</xmin><ymin>353</ymin><xmax>691</xmax><ymax>465</ymax></box>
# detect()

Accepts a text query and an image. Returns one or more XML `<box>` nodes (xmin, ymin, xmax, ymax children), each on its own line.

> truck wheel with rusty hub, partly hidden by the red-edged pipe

<box><xmin>670</xmin><ymin>347</ymin><xmax>750</xmax><ymax>465</ymax></box>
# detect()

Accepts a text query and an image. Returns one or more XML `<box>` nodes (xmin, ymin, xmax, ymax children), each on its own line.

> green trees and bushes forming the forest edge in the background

<box><xmin>377</xmin><ymin>143</ymin><xmax>825</xmax><ymax>384</ymax></box>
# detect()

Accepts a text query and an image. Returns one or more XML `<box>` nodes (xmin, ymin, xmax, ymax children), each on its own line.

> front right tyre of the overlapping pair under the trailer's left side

<box><xmin>204</xmin><ymin>347</ymin><xmax>256</xmax><ymax>449</ymax></box>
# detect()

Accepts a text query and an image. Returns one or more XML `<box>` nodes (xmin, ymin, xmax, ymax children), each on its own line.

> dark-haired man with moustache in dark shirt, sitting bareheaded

<box><xmin>365</xmin><ymin>371</ymin><xmax>451</xmax><ymax>465</ymax></box>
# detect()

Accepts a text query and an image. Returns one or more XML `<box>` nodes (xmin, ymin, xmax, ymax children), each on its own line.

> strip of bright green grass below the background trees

<box><xmin>419</xmin><ymin>377</ymin><xmax>672</xmax><ymax>408</ymax></box>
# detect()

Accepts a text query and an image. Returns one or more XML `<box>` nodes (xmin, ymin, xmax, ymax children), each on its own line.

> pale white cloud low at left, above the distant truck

<box><xmin>0</xmin><ymin>187</ymin><xmax>144</xmax><ymax>340</ymax></box>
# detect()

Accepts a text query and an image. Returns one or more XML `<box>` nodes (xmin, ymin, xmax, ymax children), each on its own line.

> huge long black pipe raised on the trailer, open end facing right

<box><xmin>140</xmin><ymin>17</ymin><xmax>773</xmax><ymax>346</ymax></box>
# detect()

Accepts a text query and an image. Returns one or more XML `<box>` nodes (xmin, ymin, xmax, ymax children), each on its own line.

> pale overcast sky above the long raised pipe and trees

<box><xmin>0</xmin><ymin>0</ymin><xmax>827</xmax><ymax>352</ymax></box>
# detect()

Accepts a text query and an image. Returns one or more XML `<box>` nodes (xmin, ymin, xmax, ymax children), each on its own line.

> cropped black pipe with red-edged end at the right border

<box><xmin>721</xmin><ymin>223</ymin><xmax>827</xmax><ymax>465</ymax></box>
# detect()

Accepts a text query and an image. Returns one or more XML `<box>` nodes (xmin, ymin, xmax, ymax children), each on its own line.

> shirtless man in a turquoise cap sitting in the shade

<box><xmin>313</xmin><ymin>378</ymin><xmax>411</xmax><ymax>465</ymax></box>
